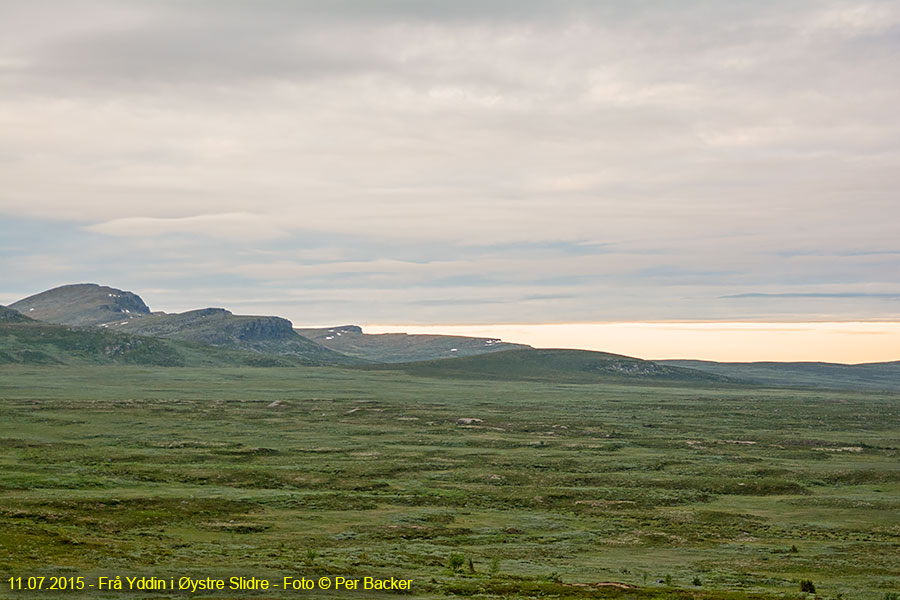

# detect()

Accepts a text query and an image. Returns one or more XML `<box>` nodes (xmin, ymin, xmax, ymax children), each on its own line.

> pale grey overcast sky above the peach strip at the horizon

<box><xmin>0</xmin><ymin>0</ymin><xmax>900</xmax><ymax>358</ymax></box>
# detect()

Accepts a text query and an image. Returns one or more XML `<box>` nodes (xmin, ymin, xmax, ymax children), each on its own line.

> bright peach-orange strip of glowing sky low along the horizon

<box><xmin>363</xmin><ymin>321</ymin><xmax>900</xmax><ymax>364</ymax></box>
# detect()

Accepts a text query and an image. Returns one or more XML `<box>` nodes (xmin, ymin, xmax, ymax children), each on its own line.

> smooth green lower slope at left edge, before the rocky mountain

<box><xmin>0</xmin><ymin>307</ymin><xmax>301</xmax><ymax>367</ymax></box>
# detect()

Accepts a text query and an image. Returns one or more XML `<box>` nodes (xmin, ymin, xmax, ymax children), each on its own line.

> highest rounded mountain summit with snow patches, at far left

<box><xmin>9</xmin><ymin>283</ymin><xmax>150</xmax><ymax>325</ymax></box>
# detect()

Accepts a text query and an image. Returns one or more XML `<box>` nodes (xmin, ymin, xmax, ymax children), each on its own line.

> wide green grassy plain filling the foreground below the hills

<box><xmin>0</xmin><ymin>365</ymin><xmax>900</xmax><ymax>600</ymax></box>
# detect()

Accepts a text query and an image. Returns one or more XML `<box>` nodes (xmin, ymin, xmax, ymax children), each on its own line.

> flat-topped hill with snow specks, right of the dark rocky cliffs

<box><xmin>296</xmin><ymin>325</ymin><xmax>530</xmax><ymax>363</ymax></box>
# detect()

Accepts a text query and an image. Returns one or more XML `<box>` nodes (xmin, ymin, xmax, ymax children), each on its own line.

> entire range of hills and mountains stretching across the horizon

<box><xmin>8</xmin><ymin>284</ymin><xmax>900</xmax><ymax>392</ymax></box>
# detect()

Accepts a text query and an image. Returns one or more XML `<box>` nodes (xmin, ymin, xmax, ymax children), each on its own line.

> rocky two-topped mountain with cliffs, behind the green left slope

<box><xmin>10</xmin><ymin>283</ymin><xmax>365</xmax><ymax>365</ymax></box>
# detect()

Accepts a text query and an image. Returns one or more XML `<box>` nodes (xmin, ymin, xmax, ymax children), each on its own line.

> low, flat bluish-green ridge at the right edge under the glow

<box><xmin>656</xmin><ymin>360</ymin><xmax>900</xmax><ymax>391</ymax></box>
